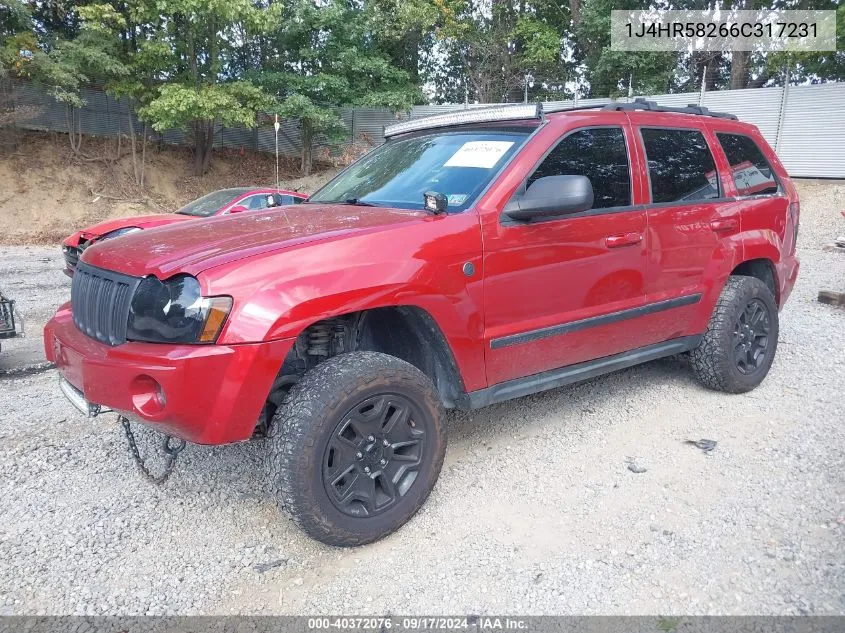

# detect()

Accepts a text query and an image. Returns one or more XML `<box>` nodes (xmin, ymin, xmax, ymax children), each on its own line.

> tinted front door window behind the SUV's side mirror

<box><xmin>528</xmin><ymin>127</ymin><xmax>631</xmax><ymax>209</ymax></box>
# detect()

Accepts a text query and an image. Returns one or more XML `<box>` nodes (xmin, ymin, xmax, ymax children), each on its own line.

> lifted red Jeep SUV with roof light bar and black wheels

<box><xmin>44</xmin><ymin>101</ymin><xmax>798</xmax><ymax>545</ymax></box>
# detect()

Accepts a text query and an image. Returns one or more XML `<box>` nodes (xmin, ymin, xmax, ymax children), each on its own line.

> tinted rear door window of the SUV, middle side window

<box><xmin>640</xmin><ymin>128</ymin><xmax>719</xmax><ymax>203</ymax></box>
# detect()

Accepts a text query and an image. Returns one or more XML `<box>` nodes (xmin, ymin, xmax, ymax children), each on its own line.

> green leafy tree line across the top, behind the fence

<box><xmin>6</xmin><ymin>0</ymin><xmax>845</xmax><ymax>174</ymax></box>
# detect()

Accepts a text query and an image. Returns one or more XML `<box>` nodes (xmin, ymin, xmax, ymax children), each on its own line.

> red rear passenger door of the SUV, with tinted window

<box><xmin>637</xmin><ymin>121</ymin><xmax>740</xmax><ymax>342</ymax></box>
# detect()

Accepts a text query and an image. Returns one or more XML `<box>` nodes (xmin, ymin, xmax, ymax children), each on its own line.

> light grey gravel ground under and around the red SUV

<box><xmin>0</xmin><ymin>182</ymin><xmax>845</xmax><ymax>614</ymax></box>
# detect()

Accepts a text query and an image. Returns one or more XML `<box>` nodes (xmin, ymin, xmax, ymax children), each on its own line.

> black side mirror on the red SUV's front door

<box><xmin>505</xmin><ymin>176</ymin><xmax>593</xmax><ymax>222</ymax></box>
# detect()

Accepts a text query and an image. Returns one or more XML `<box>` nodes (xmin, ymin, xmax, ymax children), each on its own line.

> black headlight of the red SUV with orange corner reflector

<box><xmin>126</xmin><ymin>275</ymin><xmax>232</xmax><ymax>343</ymax></box>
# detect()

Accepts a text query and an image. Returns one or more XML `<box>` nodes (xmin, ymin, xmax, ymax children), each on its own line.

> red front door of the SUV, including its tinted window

<box><xmin>482</xmin><ymin>115</ymin><xmax>646</xmax><ymax>385</ymax></box>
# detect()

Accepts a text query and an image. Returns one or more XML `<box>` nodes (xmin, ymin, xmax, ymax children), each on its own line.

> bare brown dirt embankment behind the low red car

<box><xmin>0</xmin><ymin>133</ymin><xmax>336</xmax><ymax>244</ymax></box>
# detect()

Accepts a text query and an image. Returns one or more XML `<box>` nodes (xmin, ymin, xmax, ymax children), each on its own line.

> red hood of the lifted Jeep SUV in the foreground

<box><xmin>82</xmin><ymin>204</ymin><xmax>426</xmax><ymax>279</ymax></box>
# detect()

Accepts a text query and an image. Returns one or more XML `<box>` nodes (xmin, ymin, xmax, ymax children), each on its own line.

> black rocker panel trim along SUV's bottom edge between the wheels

<box><xmin>456</xmin><ymin>336</ymin><xmax>701</xmax><ymax>409</ymax></box>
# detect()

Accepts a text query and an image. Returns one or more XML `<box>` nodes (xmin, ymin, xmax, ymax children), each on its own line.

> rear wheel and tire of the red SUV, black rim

<box><xmin>690</xmin><ymin>275</ymin><xmax>779</xmax><ymax>393</ymax></box>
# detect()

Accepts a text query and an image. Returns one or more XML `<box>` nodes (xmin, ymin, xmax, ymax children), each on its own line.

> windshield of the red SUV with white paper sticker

<box><xmin>308</xmin><ymin>130</ymin><xmax>531</xmax><ymax>212</ymax></box>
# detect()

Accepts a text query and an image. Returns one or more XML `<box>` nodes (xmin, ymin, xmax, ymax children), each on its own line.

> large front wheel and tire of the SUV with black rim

<box><xmin>268</xmin><ymin>352</ymin><xmax>446</xmax><ymax>546</ymax></box>
